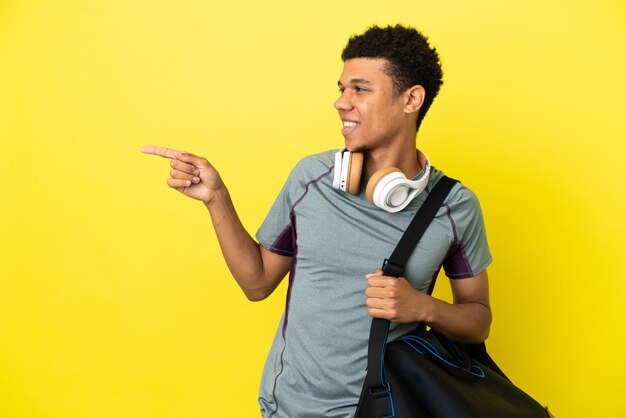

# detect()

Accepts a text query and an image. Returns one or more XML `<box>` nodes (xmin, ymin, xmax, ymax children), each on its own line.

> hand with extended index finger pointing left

<box><xmin>141</xmin><ymin>146</ymin><xmax>225</xmax><ymax>203</ymax></box>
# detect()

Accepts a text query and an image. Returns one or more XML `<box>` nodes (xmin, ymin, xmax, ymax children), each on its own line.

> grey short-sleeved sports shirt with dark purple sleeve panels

<box><xmin>256</xmin><ymin>150</ymin><xmax>491</xmax><ymax>418</ymax></box>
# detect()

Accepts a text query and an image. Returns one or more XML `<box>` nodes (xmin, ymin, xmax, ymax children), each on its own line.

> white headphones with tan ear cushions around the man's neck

<box><xmin>333</xmin><ymin>147</ymin><xmax>430</xmax><ymax>213</ymax></box>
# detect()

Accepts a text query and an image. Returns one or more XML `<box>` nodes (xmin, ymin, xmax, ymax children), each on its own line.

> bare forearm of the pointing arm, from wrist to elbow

<box><xmin>205</xmin><ymin>186</ymin><xmax>274</xmax><ymax>300</ymax></box>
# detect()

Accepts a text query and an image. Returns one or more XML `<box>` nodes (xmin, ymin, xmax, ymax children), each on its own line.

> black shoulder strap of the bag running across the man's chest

<box><xmin>357</xmin><ymin>176</ymin><xmax>458</xmax><ymax>417</ymax></box>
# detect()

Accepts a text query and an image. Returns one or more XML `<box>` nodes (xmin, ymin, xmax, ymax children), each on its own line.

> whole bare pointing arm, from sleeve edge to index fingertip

<box><xmin>141</xmin><ymin>146</ymin><xmax>291</xmax><ymax>301</ymax></box>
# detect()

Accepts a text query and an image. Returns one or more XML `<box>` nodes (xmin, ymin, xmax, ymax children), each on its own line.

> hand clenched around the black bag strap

<box><xmin>365</xmin><ymin>269</ymin><xmax>432</xmax><ymax>324</ymax></box>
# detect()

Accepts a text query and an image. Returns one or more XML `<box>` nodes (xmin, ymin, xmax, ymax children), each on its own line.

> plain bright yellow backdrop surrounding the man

<box><xmin>0</xmin><ymin>0</ymin><xmax>626</xmax><ymax>418</ymax></box>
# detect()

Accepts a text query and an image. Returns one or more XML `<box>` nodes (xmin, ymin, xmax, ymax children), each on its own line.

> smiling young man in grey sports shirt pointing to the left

<box><xmin>143</xmin><ymin>26</ymin><xmax>491</xmax><ymax>418</ymax></box>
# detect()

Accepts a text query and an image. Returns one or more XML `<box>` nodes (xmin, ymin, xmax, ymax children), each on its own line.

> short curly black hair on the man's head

<box><xmin>341</xmin><ymin>25</ymin><xmax>443</xmax><ymax>130</ymax></box>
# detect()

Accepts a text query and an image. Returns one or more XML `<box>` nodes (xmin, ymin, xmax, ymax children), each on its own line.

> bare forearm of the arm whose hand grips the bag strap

<box><xmin>424</xmin><ymin>297</ymin><xmax>491</xmax><ymax>344</ymax></box>
